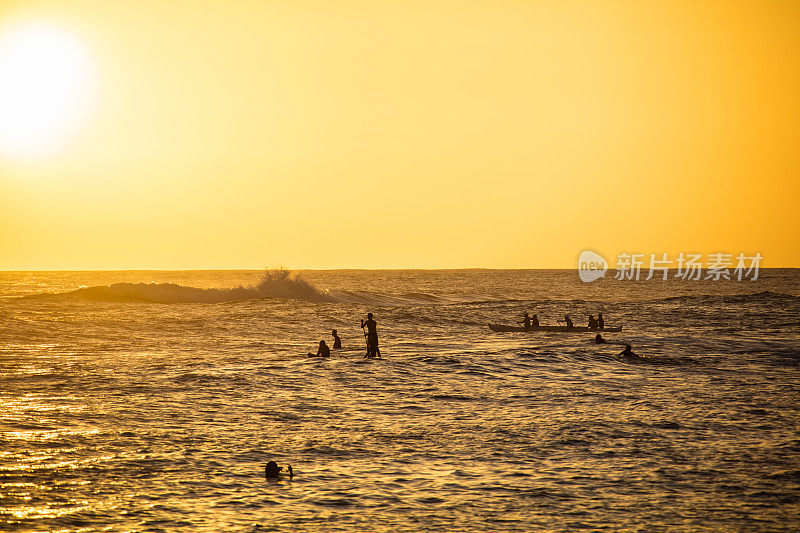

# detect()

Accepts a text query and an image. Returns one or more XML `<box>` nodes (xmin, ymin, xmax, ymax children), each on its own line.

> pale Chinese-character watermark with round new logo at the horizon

<box><xmin>578</xmin><ymin>250</ymin><xmax>764</xmax><ymax>282</ymax></box>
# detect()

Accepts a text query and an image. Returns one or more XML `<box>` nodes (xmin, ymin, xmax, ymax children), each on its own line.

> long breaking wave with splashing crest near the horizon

<box><xmin>29</xmin><ymin>270</ymin><xmax>335</xmax><ymax>303</ymax></box>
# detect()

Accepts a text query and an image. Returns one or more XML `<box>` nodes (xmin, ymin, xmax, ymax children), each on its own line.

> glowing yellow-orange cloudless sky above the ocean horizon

<box><xmin>0</xmin><ymin>0</ymin><xmax>800</xmax><ymax>269</ymax></box>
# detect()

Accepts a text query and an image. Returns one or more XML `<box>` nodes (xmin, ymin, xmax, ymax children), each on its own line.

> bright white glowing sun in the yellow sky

<box><xmin>0</xmin><ymin>23</ymin><xmax>92</xmax><ymax>158</ymax></box>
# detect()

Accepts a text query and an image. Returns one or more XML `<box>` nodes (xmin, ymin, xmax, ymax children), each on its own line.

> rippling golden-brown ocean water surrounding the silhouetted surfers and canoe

<box><xmin>0</xmin><ymin>269</ymin><xmax>800</xmax><ymax>532</ymax></box>
